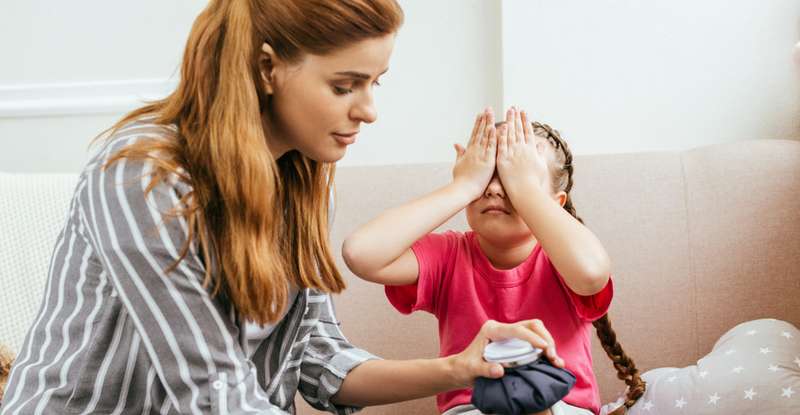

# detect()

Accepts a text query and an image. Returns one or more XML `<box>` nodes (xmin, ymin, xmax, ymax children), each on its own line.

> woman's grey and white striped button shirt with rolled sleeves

<box><xmin>0</xmin><ymin>122</ymin><xmax>376</xmax><ymax>415</ymax></box>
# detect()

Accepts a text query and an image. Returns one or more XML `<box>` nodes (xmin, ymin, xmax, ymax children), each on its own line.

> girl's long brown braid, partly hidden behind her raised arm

<box><xmin>532</xmin><ymin>122</ymin><xmax>647</xmax><ymax>415</ymax></box>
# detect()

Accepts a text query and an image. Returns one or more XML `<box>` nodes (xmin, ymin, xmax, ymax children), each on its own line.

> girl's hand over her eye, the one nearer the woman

<box><xmin>453</xmin><ymin>108</ymin><xmax>497</xmax><ymax>201</ymax></box>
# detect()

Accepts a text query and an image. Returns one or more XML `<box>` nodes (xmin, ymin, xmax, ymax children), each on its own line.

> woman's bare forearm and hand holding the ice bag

<box><xmin>333</xmin><ymin>320</ymin><xmax>564</xmax><ymax>406</ymax></box>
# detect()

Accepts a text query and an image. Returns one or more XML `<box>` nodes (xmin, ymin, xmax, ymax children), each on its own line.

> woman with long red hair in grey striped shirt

<box><xmin>0</xmin><ymin>0</ymin><xmax>555</xmax><ymax>415</ymax></box>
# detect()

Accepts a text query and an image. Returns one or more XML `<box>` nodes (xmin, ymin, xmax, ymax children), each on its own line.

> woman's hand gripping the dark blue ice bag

<box><xmin>452</xmin><ymin>320</ymin><xmax>564</xmax><ymax>387</ymax></box>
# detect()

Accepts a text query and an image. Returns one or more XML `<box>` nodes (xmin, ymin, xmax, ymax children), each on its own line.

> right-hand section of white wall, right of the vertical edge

<box><xmin>502</xmin><ymin>0</ymin><xmax>800</xmax><ymax>153</ymax></box>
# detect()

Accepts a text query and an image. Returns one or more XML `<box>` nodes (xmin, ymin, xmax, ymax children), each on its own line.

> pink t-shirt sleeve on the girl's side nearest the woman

<box><xmin>385</xmin><ymin>232</ymin><xmax>459</xmax><ymax>314</ymax></box>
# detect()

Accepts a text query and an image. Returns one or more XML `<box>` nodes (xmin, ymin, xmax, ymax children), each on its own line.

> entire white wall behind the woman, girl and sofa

<box><xmin>0</xmin><ymin>0</ymin><xmax>800</xmax><ymax>172</ymax></box>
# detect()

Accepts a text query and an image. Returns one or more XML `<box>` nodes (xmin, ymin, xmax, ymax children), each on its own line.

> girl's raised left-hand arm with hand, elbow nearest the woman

<box><xmin>342</xmin><ymin>110</ymin><xmax>497</xmax><ymax>285</ymax></box>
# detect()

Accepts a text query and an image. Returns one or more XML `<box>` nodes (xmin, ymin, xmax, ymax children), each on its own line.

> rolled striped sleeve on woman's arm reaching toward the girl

<box><xmin>299</xmin><ymin>293</ymin><xmax>378</xmax><ymax>414</ymax></box>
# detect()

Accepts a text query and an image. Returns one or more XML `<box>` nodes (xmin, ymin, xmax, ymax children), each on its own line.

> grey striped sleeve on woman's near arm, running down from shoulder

<box><xmin>79</xmin><ymin>147</ymin><xmax>285</xmax><ymax>414</ymax></box>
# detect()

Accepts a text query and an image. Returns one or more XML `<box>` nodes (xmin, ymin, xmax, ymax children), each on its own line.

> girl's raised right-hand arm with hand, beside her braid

<box><xmin>497</xmin><ymin>108</ymin><xmax>611</xmax><ymax>295</ymax></box>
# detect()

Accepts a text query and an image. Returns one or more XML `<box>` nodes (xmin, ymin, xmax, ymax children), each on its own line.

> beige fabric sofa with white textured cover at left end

<box><xmin>0</xmin><ymin>140</ymin><xmax>800</xmax><ymax>414</ymax></box>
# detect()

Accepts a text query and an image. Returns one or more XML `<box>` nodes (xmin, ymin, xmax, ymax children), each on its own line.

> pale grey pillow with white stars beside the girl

<box><xmin>601</xmin><ymin>319</ymin><xmax>800</xmax><ymax>415</ymax></box>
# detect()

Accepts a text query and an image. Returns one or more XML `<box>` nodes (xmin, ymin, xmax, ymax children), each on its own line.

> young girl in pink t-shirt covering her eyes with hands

<box><xmin>343</xmin><ymin>107</ymin><xmax>644</xmax><ymax>415</ymax></box>
